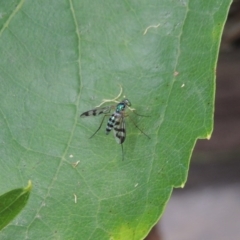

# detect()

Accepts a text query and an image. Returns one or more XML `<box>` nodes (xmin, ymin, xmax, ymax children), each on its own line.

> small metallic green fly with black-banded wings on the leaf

<box><xmin>80</xmin><ymin>99</ymin><xmax>149</xmax><ymax>159</ymax></box>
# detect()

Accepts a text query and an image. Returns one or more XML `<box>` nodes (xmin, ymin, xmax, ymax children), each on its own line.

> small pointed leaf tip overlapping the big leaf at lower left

<box><xmin>0</xmin><ymin>181</ymin><xmax>32</xmax><ymax>230</ymax></box>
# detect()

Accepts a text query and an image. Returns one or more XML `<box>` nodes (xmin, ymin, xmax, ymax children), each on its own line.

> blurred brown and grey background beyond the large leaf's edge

<box><xmin>147</xmin><ymin>0</ymin><xmax>240</xmax><ymax>240</ymax></box>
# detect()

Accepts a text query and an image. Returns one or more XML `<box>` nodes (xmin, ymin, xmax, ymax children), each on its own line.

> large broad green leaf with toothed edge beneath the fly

<box><xmin>0</xmin><ymin>0</ymin><xmax>231</xmax><ymax>240</ymax></box>
